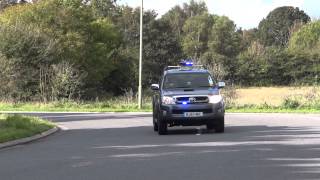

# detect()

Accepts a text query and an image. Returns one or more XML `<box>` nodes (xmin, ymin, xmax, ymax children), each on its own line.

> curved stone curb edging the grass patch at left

<box><xmin>0</xmin><ymin>127</ymin><xmax>60</xmax><ymax>149</ymax></box>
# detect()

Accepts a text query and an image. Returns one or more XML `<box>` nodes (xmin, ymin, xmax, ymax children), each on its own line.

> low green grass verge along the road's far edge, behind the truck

<box><xmin>0</xmin><ymin>100</ymin><xmax>320</xmax><ymax>113</ymax></box>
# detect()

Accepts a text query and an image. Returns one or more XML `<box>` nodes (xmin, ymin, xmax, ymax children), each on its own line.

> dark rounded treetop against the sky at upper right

<box><xmin>258</xmin><ymin>6</ymin><xmax>310</xmax><ymax>47</ymax></box>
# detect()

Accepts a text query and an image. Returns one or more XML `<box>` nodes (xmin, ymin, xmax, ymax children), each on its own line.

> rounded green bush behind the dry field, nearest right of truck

<box><xmin>236</xmin><ymin>41</ymin><xmax>291</xmax><ymax>86</ymax></box>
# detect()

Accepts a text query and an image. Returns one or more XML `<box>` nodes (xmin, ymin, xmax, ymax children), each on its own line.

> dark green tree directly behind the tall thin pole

<box><xmin>117</xmin><ymin>6</ymin><xmax>182</xmax><ymax>88</ymax></box>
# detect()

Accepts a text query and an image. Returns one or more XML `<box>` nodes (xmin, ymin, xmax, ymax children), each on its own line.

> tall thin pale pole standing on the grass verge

<box><xmin>138</xmin><ymin>0</ymin><xmax>143</xmax><ymax>109</ymax></box>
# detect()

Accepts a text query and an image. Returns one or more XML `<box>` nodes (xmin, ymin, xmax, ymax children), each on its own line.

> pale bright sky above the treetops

<box><xmin>118</xmin><ymin>0</ymin><xmax>320</xmax><ymax>29</ymax></box>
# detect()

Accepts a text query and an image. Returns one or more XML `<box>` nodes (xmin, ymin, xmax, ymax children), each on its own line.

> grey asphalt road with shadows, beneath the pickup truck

<box><xmin>0</xmin><ymin>114</ymin><xmax>320</xmax><ymax>180</ymax></box>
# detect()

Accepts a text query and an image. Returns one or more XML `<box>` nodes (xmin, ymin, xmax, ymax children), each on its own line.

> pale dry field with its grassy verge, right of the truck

<box><xmin>226</xmin><ymin>86</ymin><xmax>320</xmax><ymax>112</ymax></box>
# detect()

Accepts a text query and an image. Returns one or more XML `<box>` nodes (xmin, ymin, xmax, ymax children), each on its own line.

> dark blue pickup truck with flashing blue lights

<box><xmin>151</xmin><ymin>61</ymin><xmax>225</xmax><ymax>135</ymax></box>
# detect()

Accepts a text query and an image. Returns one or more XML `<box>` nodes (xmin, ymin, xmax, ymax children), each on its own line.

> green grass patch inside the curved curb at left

<box><xmin>0</xmin><ymin>115</ymin><xmax>54</xmax><ymax>143</ymax></box>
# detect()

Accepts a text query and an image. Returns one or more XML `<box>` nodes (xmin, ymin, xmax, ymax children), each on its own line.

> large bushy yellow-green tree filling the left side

<box><xmin>0</xmin><ymin>0</ymin><xmax>120</xmax><ymax>100</ymax></box>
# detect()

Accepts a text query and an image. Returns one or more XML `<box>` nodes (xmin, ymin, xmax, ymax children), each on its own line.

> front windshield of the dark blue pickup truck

<box><xmin>163</xmin><ymin>73</ymin><xmax>214</xmax><ymax>89</ymax></box>
